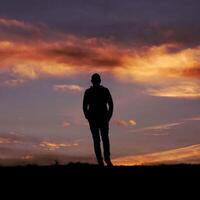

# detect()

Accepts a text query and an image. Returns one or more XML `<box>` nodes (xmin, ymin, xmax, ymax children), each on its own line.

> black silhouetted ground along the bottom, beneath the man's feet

<box><xmin>0</xmin><ymin>163</ymin><xmax>200</xmax><ymax>199</ymax></box>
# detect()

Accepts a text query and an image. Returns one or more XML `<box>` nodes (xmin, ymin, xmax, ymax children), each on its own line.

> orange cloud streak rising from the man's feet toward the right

<box><xmin>113</xmin><ymin>144</ymin><xmax>200</xmax><ymax>165</ymax></box>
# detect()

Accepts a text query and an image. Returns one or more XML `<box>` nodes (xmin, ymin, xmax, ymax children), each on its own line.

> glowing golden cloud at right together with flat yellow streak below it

<box><xmin>114</xmin><ymin>44</ymin><xmax>200</xmax><ymax>99</ymax></box>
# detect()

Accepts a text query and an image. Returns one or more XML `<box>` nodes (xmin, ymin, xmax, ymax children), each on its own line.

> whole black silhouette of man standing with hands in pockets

<box><xmin>83</xmin><ymin>74</ymin><xmax>113</xmax><ymax>166</ymax></box>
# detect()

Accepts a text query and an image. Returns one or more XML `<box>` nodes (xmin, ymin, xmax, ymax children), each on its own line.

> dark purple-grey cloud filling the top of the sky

<box><xmin>0</xmin><ymin>0</ymin><xmax>200</xmax><ymax>45</ymax></box>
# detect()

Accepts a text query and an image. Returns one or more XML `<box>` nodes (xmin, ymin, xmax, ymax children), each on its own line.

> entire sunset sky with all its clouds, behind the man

<box><xmin>0</xmin><ymin>0</ymin><xmax>200</xmax><ymax>165</ymax></box>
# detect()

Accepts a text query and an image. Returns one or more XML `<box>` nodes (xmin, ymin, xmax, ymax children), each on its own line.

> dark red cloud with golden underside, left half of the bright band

<box><xmin>0</xmin><ymin>37</ymin><xmax>121</xmax><ymax>79</ymax></box>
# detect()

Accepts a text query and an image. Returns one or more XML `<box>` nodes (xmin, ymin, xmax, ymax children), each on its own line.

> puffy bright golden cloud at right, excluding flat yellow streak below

<box><xmin>116</xmin><ymin>44</ymin><xmax>200</xmax><ymax>84</ymax></box>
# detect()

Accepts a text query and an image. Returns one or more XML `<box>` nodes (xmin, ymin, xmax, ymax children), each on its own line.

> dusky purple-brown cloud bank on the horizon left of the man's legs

<box><xmin>0</xmin><ymin>132</ymin><xmax>86</xmax><ymax>166</ymax></box>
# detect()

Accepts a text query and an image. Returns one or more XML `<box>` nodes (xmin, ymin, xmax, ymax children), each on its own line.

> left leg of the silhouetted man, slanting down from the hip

<box><xmin>89</xmin><ymin>122</ymin><xmax>104</xmax><ymax>166</ymax></box>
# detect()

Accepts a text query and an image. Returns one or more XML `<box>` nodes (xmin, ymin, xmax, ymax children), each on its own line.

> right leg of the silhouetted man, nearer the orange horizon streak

<box><xmin>100</xmin><ymin>122</ymin><xmax>112</xmax><ymax>166</ymax></box>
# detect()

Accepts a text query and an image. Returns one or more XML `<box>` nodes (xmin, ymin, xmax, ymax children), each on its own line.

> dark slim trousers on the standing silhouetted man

<box><xmin>89</xmin><ymin>120</ymin><xmax>110</xmax><ymax>163</ymax></box>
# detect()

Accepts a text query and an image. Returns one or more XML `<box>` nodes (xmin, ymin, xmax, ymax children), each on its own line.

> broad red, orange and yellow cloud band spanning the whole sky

<box><xmin>0</xmin><ymin>19</ymin><xmax>200</xmax><ymax>99</ymax></box>
